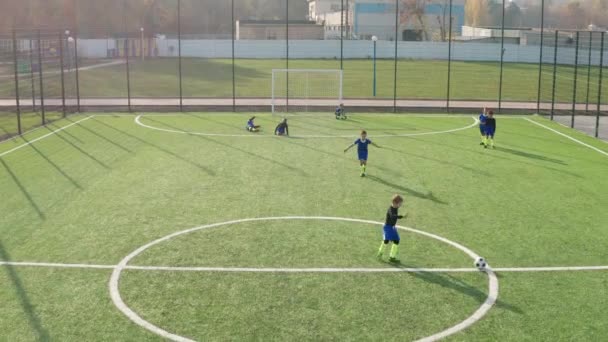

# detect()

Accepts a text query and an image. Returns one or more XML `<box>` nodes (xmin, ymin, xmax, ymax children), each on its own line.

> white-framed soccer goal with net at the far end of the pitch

<box><xmin>272</xmin><ymin>69</ymin><xmax>343</xmax><ymax>114</ymax></box>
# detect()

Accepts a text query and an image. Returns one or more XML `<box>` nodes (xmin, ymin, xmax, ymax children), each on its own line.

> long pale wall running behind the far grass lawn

<box><xmin>78</xmin><ymin>39</ymin><xmax>608</xmax><ymax>67</ymax></box>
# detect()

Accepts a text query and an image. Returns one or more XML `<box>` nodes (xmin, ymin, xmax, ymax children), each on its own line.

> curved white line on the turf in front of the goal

<box><xmin>135</xmin><ymin>115</ymin><xmax>479</xmax><ymax>139</ymax></box>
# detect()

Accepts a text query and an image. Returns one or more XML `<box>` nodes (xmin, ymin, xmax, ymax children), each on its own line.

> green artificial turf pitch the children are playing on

<box><xmin>0</xmin><ymin>113</ymin><xmax>608</xmax><ymax>341</ymax></box>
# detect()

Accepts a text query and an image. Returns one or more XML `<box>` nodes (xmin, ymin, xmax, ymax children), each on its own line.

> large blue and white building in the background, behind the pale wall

<box><xmin>308</xmin><ymin>0</ymin><xmax>465</xmax><ymax>41</ymax></box>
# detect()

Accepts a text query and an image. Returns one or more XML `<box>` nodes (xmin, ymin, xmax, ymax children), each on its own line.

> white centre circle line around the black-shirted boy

<box><xmin>109</xmin><ymin>216</ymin><xmax>498</xmax><ymax>342</ymax></box>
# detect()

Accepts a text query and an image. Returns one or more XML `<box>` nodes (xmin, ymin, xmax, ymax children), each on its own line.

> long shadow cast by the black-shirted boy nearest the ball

<box><xmin>390</xmin><ymin>263</ymin><xmax>524</xmax><ymax>314</ymax></box>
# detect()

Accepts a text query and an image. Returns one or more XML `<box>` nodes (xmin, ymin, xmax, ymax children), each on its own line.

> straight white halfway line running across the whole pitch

<box><xmin>0</xmin><ymin>261</ymin><xmax>608</xmax><ymax>273</ymax></box>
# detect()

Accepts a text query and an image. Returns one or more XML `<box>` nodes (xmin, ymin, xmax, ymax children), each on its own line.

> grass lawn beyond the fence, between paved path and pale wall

<box><xmin>0</xmin><ymin>58</ymin><xmax>608</xmax><ymax>104</ymax></box>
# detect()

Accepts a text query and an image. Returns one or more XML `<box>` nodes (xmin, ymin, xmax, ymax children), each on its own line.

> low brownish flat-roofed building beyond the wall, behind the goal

<box><xmin>236</xmin><ymin>20</ymin><xmax>324</xmax><ymax>40</ymax></box>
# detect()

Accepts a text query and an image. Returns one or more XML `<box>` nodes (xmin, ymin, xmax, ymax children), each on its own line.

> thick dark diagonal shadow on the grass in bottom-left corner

<box><xmin>0</xmin><ymin>241</ymin><xmax>51</xmax><ymax>341</ymax></box>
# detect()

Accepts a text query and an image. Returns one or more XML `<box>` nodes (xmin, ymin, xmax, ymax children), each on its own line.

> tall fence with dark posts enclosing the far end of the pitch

<box><xmin>0</xmin><ymin>0</ymin><xmax>608</xmax><ymax>139</ymax></box>
